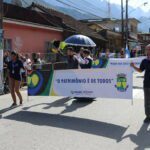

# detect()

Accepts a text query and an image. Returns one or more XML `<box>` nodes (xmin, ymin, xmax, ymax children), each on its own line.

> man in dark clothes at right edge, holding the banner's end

<box><xmin>131</xmin><ymin>44</ymin><xmax>150</xmax><ymax>123</ymax></box>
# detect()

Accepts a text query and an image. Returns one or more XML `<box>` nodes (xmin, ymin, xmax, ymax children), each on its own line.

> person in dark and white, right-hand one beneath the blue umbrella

<box><xmin>80</xmin><ymin>49</ymin><xmax>93</xmax><ymax>69</ymax></box>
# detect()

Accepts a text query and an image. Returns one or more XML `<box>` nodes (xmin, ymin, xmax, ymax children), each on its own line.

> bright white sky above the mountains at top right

<box><xmin>110</xmin><ymin>0</ymin><xmax>150</xmax><ymax>11</ymax></box>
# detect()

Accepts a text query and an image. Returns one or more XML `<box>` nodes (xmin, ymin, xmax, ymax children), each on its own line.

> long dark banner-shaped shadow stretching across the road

<box><xmin>5</xmin><ymin>111</ymin><xmax>127</xmax><ymax>141</ymax></box>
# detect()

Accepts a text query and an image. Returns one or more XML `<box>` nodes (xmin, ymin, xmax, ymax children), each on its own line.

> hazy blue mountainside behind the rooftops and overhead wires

<box><xmin>4</xmin><ymin>0</ymin><xmax>150</xmax><ymax>32</ymax></box>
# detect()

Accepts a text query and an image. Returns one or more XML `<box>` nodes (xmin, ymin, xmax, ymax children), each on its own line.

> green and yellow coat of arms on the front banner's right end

<box><xmin>115</xmin><ymin>74</ymin><xmax>129</xmax><ymax>92</ymax></box>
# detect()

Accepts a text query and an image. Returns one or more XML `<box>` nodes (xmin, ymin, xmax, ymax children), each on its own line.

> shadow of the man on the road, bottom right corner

<box><xmin>122</xmin><ymin>124</ymin><xmax>150</xmax><ymax>150</ymax></box>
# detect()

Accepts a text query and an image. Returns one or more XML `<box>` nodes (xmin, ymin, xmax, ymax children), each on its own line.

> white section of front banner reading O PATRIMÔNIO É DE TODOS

<box><xmin>50</xmin><ymin>66</ymin><xmax>133</xmax><ymax>99</ymax></box>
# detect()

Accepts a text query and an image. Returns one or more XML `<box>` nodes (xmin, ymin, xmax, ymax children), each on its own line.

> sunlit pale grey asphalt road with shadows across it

<box><xmin>0</xmin><ymin>74</ymin><xmax>150</xmax><ymax>150</ymax></box>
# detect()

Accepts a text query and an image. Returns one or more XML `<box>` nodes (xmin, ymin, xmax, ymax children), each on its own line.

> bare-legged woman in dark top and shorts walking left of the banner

<box><xmin>8</xmin><ymin>52</ymin><xmax>24</xmax><ymax>107</ymax></box>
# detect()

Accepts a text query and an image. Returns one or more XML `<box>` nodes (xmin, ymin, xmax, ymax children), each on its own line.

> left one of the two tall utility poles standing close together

<box><xmin>121</xmin><ymin>0</ymin><xmax>124</xmax><ymax>48</ymax></box>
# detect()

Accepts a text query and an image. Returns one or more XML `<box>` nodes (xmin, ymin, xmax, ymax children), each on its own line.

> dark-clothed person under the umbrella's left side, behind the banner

<box><xmin>67</xmin><ymin>47</ymin><xmax>79</xmax><ymax>69</ymax></box>
